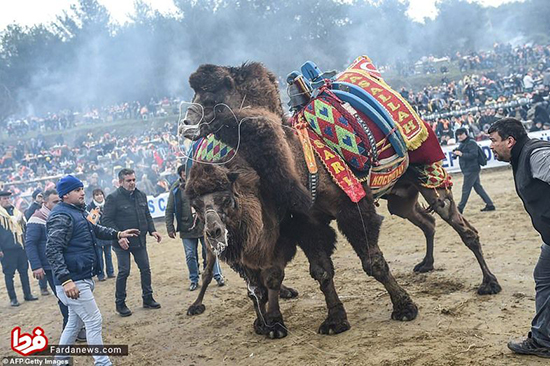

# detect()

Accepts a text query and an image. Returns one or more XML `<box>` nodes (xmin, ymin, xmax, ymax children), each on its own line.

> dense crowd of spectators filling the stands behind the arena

<box><xmin>0</xmin><ymin>44</ymin><xmax>550</xmax><ymax>209</ymax></box>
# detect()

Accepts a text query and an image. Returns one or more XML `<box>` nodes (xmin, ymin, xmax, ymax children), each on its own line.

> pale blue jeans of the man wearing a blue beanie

<box><xmin>56</xmin><ymin>279</ymin><xmax>112</xmax><ymax>366</ymax></box>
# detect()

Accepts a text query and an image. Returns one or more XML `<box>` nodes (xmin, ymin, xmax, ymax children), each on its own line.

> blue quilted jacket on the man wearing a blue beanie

<box><xmin>46</xmin><ymin>202</ymin><xmax>118</xmax><ymax>285</ymax></box>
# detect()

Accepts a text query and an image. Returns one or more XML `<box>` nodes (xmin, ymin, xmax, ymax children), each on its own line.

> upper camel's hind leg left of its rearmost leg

<box><xmin>387</xmin><ymin>186</ymin><xmax>435</xmax><ymax>273</ymax></box>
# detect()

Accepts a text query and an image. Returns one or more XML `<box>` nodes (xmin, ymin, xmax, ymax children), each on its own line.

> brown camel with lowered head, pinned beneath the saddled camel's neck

<box><xmin>185</xmin><ymin>159</ymin><xmax>306</xmax><ymax>338</ymax></box>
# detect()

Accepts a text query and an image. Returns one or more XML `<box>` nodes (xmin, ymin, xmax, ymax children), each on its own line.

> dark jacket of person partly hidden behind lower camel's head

<box><xmin>164</xmin><ymin>178</ymin><xmax>204</xmax><ymax>239</ymax></box>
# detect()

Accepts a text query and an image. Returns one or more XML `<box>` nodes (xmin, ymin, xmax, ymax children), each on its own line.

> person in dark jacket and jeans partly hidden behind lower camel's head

<box><xmin>164</xmin><ymin>165</ymin><xmax>225</xmax><ymax>291</ymax></box>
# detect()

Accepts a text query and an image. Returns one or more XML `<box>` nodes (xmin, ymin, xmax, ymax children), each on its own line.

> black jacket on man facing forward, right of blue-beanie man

<box><xmin>101</xmin><ymin>187</ymin><xmax>156</xmax><ymax>249</ymax></box>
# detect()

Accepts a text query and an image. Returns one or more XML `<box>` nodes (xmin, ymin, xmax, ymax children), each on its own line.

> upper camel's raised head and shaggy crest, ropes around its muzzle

<box><xmin>180</xmin><ymin>62</ymin><xmax>283</xmax><ymax>140</ymax></box>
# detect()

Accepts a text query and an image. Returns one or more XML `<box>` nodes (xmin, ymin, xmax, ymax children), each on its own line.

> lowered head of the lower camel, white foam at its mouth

<box><xmin>185</xmin><ymin>164</ymin><xmax>239</xmax><ymax>256</ymax></box>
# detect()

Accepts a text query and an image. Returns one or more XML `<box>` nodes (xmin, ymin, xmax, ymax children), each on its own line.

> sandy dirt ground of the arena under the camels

<box><xmin>0</xmin><ymin>169</ymin><xmax>548</xmax><ymax>366</ymax></box>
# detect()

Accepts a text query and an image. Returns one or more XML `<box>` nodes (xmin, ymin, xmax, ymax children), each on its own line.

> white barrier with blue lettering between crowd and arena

<box><xmin>147</xmin><ymin>130</ymin><xmax>550</xmax><ymax>218</ymax></box>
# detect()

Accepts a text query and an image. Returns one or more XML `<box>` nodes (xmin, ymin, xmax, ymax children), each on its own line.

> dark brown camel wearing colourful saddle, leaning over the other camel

<box><xmin>183</xmin><ymin>63</ymin><xmax>500</xmax><ymax>333</ymax></box>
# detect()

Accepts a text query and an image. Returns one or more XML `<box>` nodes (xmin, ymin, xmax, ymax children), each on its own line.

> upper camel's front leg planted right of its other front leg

<box><xmin>336</xmin><ymin>194</ymin><xmax>418</xmax><ymax>321</ymax></box>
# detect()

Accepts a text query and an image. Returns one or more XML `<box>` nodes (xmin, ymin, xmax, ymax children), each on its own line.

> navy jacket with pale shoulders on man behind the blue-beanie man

<box><xmin>25</xmin><ymin>207</ymin><xmax>51</xmax><ymax>271</ymax></box>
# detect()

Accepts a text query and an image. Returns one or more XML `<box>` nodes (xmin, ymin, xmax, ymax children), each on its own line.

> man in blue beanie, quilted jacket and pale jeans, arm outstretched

<box><xmin>46</xmin><ymin>175</ymin><xmax>138</xmax><ymax>366</ymax></box>
